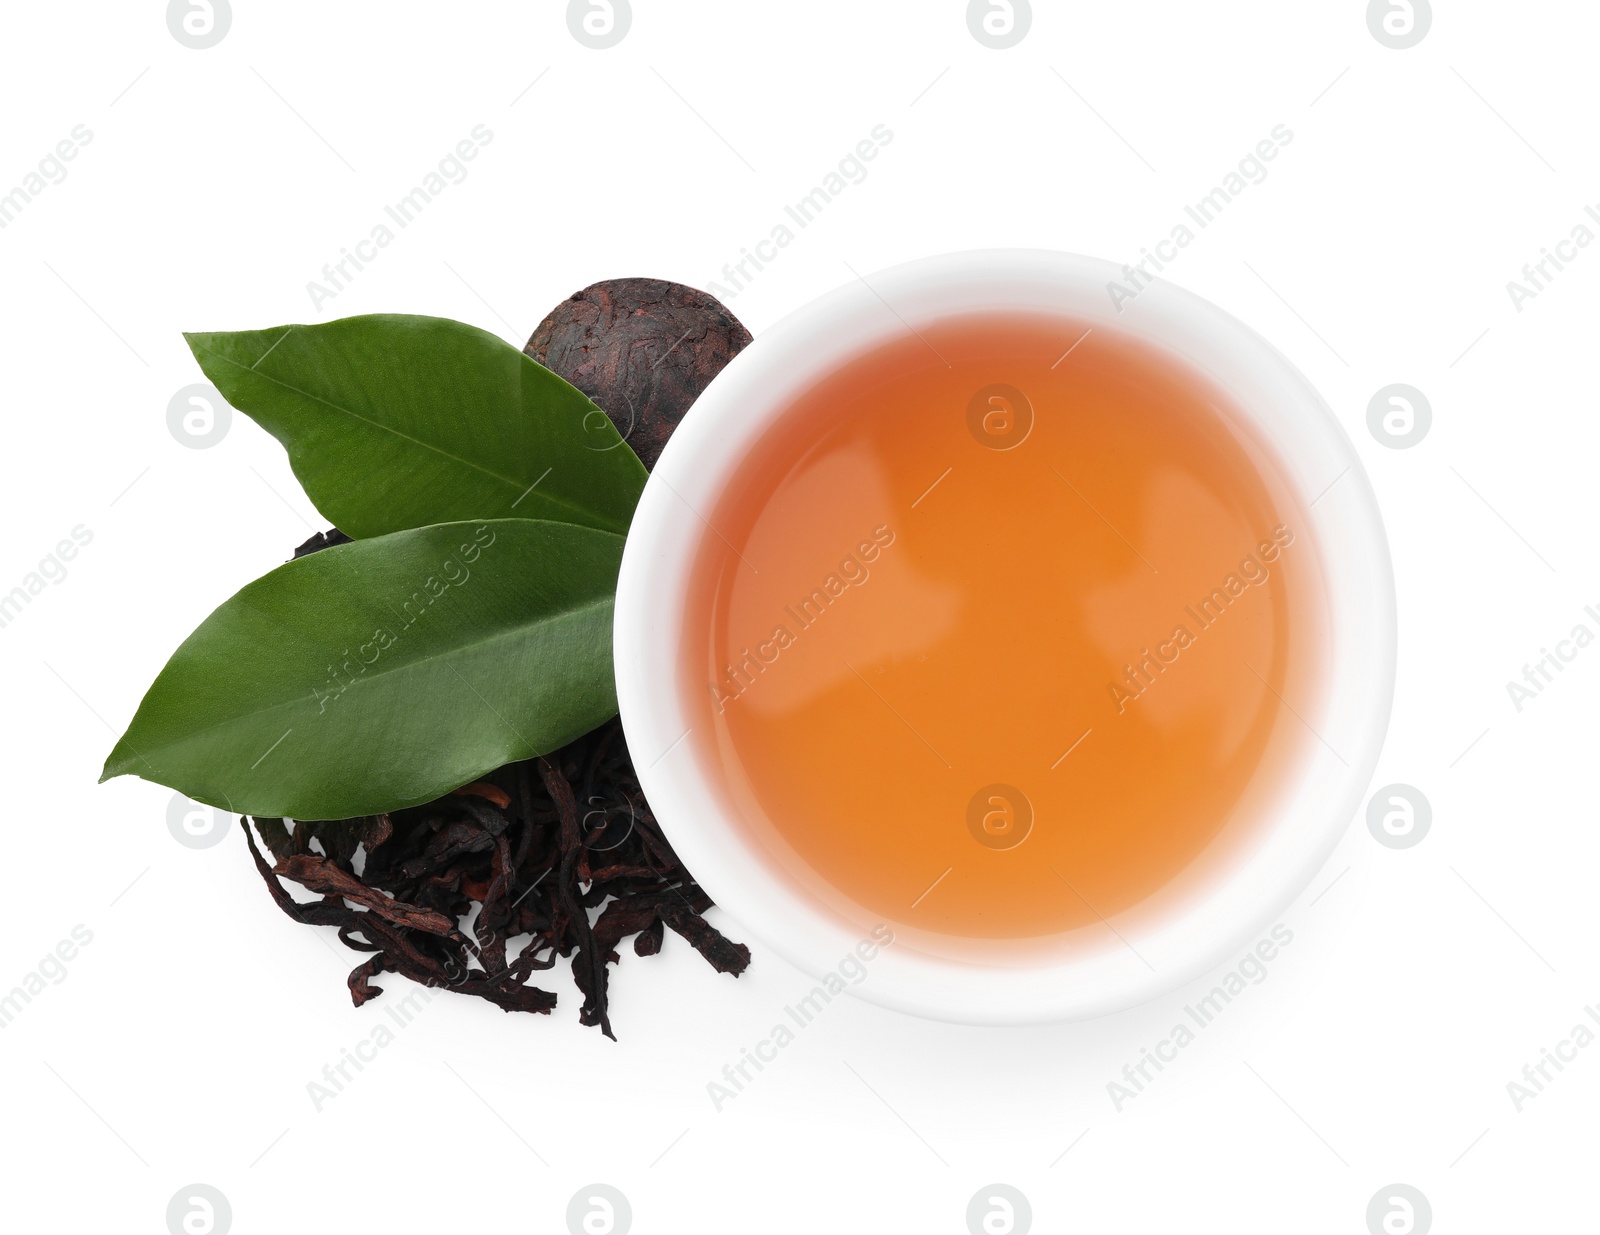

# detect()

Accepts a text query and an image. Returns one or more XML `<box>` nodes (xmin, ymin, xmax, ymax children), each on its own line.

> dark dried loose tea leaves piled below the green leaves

<box><xmin>245</xmin><ymin>703</ymin><xmax>750</xmax><ymax>1038</ymax></box>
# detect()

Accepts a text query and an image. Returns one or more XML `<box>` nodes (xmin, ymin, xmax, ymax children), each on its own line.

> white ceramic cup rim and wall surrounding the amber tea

<box><xmin>614</xmin><ymin>250</ymin><xmax>1395</xmax><ymax>1024</ymax></box>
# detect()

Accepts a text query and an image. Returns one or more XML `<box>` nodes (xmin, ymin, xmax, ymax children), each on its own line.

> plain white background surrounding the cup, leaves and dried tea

<box><xmin>0</xmin><ymin>0</ymin><xmax>1600</xmax><ymax>1235</ymax></box>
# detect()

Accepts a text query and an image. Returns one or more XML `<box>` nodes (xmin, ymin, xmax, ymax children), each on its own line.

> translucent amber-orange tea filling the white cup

<box><xmin>680</xmin><ymin>315</ymin><xmax>1322</xmax><ymax>941</ymax></box>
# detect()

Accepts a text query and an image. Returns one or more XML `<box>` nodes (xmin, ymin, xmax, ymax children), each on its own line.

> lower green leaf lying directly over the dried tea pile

<box><xmin>101</xmin><ymin>518</ymin><xmax>622</xmax><ymax>819</ymax></box>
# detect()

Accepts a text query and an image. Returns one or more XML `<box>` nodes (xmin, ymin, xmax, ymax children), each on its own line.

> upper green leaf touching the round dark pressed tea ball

<box><xmin>184</xmin><ymin>314</ymin><xmax>646</xmax><ymax>539</ymax></box>
